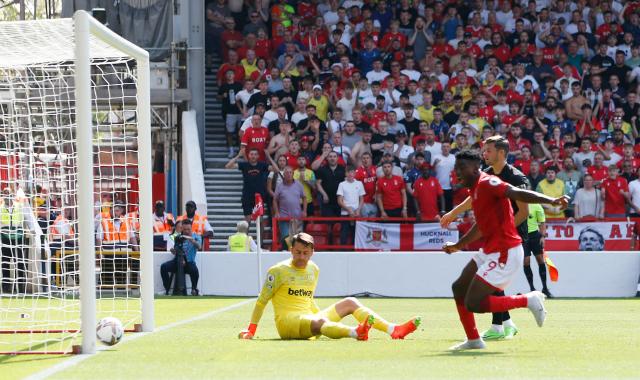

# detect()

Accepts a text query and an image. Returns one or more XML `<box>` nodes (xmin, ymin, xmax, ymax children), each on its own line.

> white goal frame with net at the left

<box><xmin>0</xmin><ymin>12</ymin><xmax>153</xmax><ymax>354</ymax></box>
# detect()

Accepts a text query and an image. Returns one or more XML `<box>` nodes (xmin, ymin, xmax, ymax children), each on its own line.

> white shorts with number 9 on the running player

<box><xmin>473</xmin><ymin>245</ymin><xmax>524</xmax><ymax>290</ymax></box>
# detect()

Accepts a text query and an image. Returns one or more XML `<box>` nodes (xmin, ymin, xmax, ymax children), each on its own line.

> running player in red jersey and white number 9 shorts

<box><xmin>442</xmin><ymin>150</ymin><xmax>568</xmax><ymax>350</ymax></box>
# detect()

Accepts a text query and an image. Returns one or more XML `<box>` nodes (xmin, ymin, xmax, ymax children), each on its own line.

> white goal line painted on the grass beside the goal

<box><xmin>25</xmin><ymin>298</ymin><xmax>255</xmax><ymax>380</ymax></box>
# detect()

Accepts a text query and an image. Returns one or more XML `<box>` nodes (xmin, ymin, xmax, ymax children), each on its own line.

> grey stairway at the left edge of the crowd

<box><xmin>204</xmin><ymin>58</ymin><xmax>271</xmax><ymax>251</ymax></box>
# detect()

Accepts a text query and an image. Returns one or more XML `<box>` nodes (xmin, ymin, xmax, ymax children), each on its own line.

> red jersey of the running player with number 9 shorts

<box><xmin>471</xmin><ymin>172</ymin><xmax>522</xmax><ymax>254</ymax></box>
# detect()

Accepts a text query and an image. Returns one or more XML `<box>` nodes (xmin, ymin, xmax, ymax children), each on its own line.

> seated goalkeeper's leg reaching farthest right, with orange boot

<box><xmin>328</xmin><ymin>297</ymin><xmax>421</xmax><ymax>339</ymax></box>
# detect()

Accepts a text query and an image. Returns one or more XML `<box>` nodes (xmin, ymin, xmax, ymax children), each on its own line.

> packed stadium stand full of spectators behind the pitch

<box><xmin>205</xmin><ymin>0</ymin><xmax>640</xmax><ymax>249</ymax></box>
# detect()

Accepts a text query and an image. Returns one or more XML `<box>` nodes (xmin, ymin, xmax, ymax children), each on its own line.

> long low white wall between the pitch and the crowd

<box><xmin>154</xmin><ymin>252</ymin><xmax>640</xmax><ymax>297</ymax></box>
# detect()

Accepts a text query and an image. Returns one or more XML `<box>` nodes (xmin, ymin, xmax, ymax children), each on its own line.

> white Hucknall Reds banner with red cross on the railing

<box><xmin>355</xmin><ymin>222</ymin><xmax>458</xmax><ymax>251</ymax></box>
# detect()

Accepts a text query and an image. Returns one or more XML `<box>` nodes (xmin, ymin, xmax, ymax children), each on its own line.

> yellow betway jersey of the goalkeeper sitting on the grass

<box><xmin>251</xmin><ymin>259</ymin><xmax>320</xmax><ymax>323</ymax></box>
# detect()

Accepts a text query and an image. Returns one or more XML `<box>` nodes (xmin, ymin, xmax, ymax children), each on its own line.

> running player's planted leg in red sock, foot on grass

<box><xmin>449</xmin><ymin>260</ymin><xmax>486</xmax><ymax>351</ymax></box>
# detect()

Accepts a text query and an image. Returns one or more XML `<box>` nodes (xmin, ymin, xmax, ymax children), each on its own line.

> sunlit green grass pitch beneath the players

<box><xmin>0</xmin><ymin>297</ymin><xmax>640</xmax><ymax>379</ymax></box>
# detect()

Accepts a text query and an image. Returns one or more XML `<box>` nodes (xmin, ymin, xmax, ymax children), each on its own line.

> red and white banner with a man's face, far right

<box><xmin>544</xmin><ymin>221</ymin><xmax>634</xmax><ymax>251</ymax></box>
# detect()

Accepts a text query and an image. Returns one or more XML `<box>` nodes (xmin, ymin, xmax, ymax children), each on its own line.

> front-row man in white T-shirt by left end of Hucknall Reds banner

<box><xmin>336</xmin><ymin>165</ymin><xmax>365</xmax><ymax>244</ymax></box>
